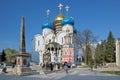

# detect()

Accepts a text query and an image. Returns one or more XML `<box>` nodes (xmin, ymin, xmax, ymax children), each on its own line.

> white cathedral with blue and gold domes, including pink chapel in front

<box><xmin>33</xmin><ymin>4</ymin><xmax>80</xmax><ymax>64</ymax></box>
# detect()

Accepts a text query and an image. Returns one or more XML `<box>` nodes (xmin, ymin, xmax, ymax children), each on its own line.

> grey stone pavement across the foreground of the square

<box><xmin>0</xmin><ymin>68</ymin><xmax>120</xmax><ymax>80</ymax></box>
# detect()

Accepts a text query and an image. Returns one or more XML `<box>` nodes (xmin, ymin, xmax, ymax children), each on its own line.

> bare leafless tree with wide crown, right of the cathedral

<box><xmin>76</xmin><ymin>29</ymin><xmax>97</xmax><ymax>64</ymax></box>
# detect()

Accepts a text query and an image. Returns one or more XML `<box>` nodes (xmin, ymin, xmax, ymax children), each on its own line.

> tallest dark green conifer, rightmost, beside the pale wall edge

<box><xmin>106</xmin><ymin>31</ymin><xmax>115</xmax><ymax>62</ymax></box>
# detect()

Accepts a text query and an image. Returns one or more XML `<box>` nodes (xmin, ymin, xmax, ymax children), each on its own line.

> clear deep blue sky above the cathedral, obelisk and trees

<box><xmin>0</xmin><ymin>0</ymin><xmax>120</xmax><ymax>52</ymax></box>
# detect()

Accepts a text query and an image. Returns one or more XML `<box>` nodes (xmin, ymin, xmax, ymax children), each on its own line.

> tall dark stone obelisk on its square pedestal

<box><xmin>16</xmin><ymin>16</ymin><xmax>31</xmax><ymax>75</ymax></box>
